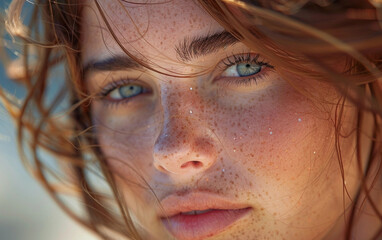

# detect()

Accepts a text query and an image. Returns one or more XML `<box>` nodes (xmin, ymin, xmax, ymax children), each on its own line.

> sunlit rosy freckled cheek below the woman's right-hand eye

<box><xmin>211</xmin><ymin>81</ymin><xmax>340</xmax><ymax>190</ymax></box>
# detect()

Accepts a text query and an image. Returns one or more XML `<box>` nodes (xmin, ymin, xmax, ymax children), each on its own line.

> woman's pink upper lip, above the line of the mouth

<box><xmin>159</xmin><ymin>191</ymin><xmax>249</xmax><ymax>218</ymax></box>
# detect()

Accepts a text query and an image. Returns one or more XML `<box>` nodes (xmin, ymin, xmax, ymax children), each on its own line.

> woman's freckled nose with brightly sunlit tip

<box><xmin>153</xmin><ymin>86</ymin><xmax>217</xmax><ymax>176</ymax></box>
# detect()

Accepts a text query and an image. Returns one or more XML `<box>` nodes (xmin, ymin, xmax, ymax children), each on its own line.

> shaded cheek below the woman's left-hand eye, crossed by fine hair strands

<box><xmin>92</xmin><ymin>102</ymin><xmax>161</xmax><ymax>179</ymax></box>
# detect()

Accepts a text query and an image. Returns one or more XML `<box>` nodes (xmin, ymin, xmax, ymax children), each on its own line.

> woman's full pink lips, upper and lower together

<box><xmin>160</xmin><ymin>192</ymin><xmax>252</xmax><ymax>240</ymax></box>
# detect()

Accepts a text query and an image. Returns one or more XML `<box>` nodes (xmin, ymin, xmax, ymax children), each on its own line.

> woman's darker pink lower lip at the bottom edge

<box><xmin>162</xmin><ymin>208</ymin><xmax>251</xmax><ymax>240</ymax></box>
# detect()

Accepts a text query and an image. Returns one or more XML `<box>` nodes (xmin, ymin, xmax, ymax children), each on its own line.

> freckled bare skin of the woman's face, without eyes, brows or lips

<box><xmin>82</xmin><ymin>0</ymin><xmax>357</xmax><ymax>240</ymax></box>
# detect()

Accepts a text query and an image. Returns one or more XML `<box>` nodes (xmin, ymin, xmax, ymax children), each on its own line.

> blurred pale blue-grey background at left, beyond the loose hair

<box><xmin>0</xmin><ymin>0</ymin><xmax>99</xmax><ymax>240</ymax></box>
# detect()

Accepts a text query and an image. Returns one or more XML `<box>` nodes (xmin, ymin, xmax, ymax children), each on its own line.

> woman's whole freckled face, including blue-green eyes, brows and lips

<box><xmin>82</xmin><ymin>0</ymin><xmax>362</xmax><ymax>240</ymax></box>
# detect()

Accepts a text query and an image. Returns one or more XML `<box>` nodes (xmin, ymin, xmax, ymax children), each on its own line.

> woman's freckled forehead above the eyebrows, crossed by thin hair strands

<box><xmin>82</xmin><ymin>0</ymin><xmax>223</xmax><ymax>61</ymax></box>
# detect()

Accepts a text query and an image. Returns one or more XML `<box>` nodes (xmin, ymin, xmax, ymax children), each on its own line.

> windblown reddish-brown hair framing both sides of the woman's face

<box><xmin>0</xmin><ymin>0</ymin><xmax>382</xmax><ymax>239</ymax></box>
